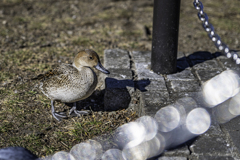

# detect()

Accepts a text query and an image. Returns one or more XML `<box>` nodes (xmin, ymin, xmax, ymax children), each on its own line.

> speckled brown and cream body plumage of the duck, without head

<box><xmin>35</xmin><ymin>64</ymin><xmax>97</xmax><ymax>102</ymax></box>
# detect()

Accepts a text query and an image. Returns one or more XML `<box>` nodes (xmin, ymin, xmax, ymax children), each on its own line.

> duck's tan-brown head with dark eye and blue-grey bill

<box><xmin>73</xmin><ymin>49</ymin><xmax>110</xmax><ymax>74</ymax></box>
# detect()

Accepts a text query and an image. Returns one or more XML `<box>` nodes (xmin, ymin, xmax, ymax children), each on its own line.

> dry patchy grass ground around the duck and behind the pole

<box><xmin>0</xmin><ymin>0</ymin><xmax>240</xmax><ymax>157</ymax></box>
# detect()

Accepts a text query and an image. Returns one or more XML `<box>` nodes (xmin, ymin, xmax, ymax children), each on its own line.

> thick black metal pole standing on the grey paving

<box><xmin>151</xmin><ymin>0</ymin><xmax>181</xmax><ymax>74</ymax></box>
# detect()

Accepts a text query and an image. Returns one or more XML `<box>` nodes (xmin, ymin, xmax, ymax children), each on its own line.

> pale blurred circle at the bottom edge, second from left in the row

<box><xmin>70</xmin><ymin>143</ymin><xmax>96</xmax><ymax>160</ymax></box>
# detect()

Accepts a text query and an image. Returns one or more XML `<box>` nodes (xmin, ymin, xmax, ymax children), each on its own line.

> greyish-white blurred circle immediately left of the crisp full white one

<box><xmin>154</xmin><ymin>105</ymin><xmax>180</xmax><ymax>132</ymax></box>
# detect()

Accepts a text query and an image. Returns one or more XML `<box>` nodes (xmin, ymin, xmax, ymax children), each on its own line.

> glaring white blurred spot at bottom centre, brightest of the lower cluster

<box><xmin>116</xmin><ymin>122</ymin><xmax>146</xmax><ymax>148</ymax></box>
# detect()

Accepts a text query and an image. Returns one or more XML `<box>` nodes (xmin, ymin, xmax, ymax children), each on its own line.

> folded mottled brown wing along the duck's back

<box><xmin>32</xmin><ymin>64</ymin><xmax>77</xmax><ymax>81</ymax></box>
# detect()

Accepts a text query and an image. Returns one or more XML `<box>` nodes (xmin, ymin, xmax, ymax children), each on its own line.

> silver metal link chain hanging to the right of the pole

<box><xmin>193</xmin><ymin>0</ymin><xmax>240</xmax><ymax>64</ymax></box>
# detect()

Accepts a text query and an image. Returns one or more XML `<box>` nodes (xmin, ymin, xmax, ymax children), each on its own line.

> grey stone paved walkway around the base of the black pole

<box><xmin>104</xmin><ymin>49</ymin><xmax>240</xmax><ymax>160</ymax></box>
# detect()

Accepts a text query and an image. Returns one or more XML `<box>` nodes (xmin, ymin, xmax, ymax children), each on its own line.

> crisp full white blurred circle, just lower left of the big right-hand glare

<box><xmin>186</xmin><ymin>108</ymin><xmax>211</xmax><ymax>135</ymax></box>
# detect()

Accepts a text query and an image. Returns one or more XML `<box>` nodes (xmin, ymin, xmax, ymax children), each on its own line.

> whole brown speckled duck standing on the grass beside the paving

<box><xmin>32</xmin><ymin>49</ymin><xmax>110</xmax><ymax>121</ymax></box>
